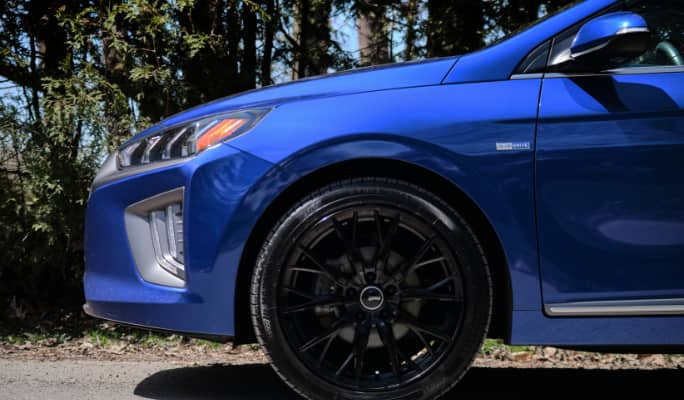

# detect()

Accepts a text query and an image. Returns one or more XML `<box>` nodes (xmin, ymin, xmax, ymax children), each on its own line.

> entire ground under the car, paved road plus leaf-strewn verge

<box><xmin>0</xmin><ymin>318</ymin><xmax>684</xmax><ymax>400</ymax></box>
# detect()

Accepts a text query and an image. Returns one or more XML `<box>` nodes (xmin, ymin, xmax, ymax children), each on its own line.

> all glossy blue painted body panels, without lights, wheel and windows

<box><xmin>84</xmin><ymin>0</ymin><xmax>684</xmax><ymax>345</ymax></box>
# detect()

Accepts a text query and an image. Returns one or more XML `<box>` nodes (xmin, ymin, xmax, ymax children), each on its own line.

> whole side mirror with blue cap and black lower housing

<box><xmin>551</xmin><ymin>12</ymin><xmax>651</xmax><ymax>72</ymax></box>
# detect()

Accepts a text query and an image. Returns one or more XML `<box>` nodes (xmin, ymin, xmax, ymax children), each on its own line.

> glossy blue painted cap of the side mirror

<box><xmin>570</xmin><ymin>11</ymin><xmax>648</xmax><ymax>56</ymax></box>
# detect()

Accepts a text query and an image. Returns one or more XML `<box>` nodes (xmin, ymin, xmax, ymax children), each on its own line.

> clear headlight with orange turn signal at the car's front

<box><xmin>117</xmin><ymin>109</ymin><xmax>269</xmax><ymax>168</ymax></box>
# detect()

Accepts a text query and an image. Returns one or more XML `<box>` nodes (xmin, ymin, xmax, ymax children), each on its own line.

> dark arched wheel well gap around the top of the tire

<box><xmin>234</xmin><ymin>158</ymin><xmax>513</xmax><ymax>344</ymax></box>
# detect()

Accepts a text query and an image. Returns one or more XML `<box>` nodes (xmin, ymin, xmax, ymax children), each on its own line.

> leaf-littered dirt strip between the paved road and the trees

<box><xmin>0</xmin><ymin>332</ymin><xmax>684</xmax><ymax>370</ymax></box>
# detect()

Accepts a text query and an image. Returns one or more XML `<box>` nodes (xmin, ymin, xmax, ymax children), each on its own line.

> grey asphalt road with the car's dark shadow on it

<box><xmin>0</xmin><ymin>360</ymin><xmax>684</xmax><ymax>400</ymax></box>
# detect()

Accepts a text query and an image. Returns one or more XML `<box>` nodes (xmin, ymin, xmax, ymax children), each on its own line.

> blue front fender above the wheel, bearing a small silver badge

<box><xmin>230</xmin><ymin>79</ymin><xmax>541</xmax><ymax>310</ymax></box>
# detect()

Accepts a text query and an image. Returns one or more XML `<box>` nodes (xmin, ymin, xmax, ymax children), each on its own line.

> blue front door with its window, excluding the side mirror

<box><xmin>535</xmin><ymin>0</ymin><xmax>684</xmax><ymax>315</ymax></box>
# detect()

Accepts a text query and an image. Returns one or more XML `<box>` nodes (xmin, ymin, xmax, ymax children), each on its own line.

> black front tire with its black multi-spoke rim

<box><xmin>251</xmin><ymin>177</ymin><xmax>492</xmax><ymax>400</ymax></box>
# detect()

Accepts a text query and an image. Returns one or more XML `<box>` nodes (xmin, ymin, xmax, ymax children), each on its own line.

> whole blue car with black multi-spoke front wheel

<box><xmin>84</xmin><ymin>0</ymin><xmax>684</xmax><ymax>400</ymax></box>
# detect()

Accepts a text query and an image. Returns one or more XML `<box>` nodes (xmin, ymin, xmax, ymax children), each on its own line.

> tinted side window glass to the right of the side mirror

<box><xmin>623</xmin><ymin>0</ymin><xmax>684</xmax><ymax>67</ymax></box>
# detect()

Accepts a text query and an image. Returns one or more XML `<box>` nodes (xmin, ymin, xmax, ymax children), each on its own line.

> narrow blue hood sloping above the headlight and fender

<box><xmin>131</xmin><ymin>57</ymin><xmax>458</xmax><ymax>140</ymax></box>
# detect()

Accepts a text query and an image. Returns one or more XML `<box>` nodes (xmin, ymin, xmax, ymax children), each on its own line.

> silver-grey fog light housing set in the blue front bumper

<box><xmin>124</xmin><ymin>188</ymin><xmax>186</xmax><ymax>287</ymax></box>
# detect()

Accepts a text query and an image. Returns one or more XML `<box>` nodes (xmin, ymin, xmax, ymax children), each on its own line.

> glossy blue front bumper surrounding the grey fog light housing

<box><xmin>83</xmin><ymin>144</ymin><xmax>272</xmax><ymax>336</ymax></box>
